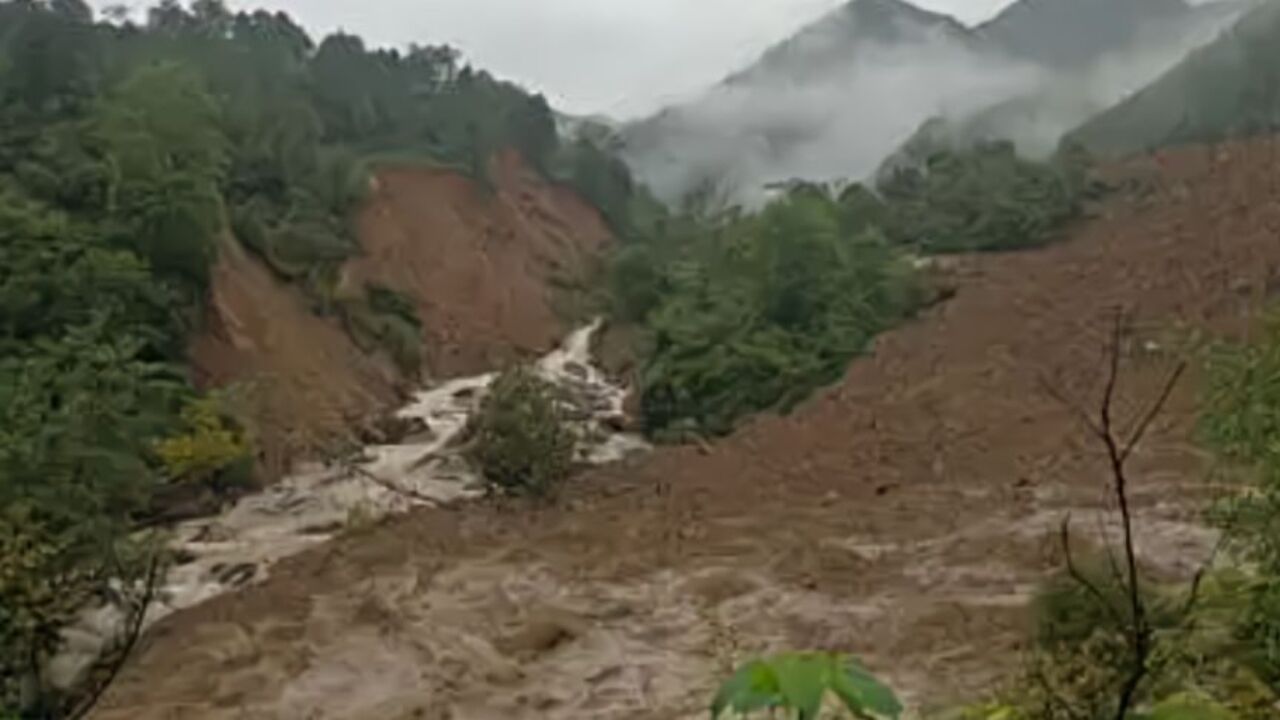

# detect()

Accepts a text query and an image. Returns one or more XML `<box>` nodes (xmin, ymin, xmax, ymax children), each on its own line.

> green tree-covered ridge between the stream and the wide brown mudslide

<box><xmin>599</xmin><ymin>142</ymin><xmax>1088</xmax><ymax>438</ymax></box>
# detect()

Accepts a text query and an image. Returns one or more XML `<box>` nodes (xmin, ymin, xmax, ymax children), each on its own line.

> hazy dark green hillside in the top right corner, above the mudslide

<box><xmin>1070</xmin><ymin>0</ymin><xmax>1280</xmax><ymax>154</ymax></box>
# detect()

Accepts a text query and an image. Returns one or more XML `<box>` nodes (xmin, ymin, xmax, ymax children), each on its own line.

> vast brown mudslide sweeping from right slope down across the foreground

<box><xmin>97</xmin><ymin>137</ymin><xmax>1280</xmax><ymax>720</ymax></box>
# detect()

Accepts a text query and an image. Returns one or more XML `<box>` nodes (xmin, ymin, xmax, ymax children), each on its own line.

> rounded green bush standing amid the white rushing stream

<box><xmin>467</xmin><ymin>368</ymin><xmax>577</xmax><ymax>496</ymax></box>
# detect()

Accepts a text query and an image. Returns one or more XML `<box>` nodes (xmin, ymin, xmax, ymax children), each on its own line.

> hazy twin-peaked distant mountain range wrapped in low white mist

<box><xmin>617</xmin><ymin>0</ymin><xmax>1248</xmax><ymax>201</ymax></box>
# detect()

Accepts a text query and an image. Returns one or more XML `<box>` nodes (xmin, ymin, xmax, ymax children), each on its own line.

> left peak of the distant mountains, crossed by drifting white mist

<box><xmin>621</xmin><ymin>0</ymin><xmax>1034</xmax><ymax>200</ymax></box>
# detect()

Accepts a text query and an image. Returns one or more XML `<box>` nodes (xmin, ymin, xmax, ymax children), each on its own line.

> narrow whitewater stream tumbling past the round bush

<box><xmin>47</xmin><ymin>320</ymin><xmax>649</xmax><ymax>687</ymax></box>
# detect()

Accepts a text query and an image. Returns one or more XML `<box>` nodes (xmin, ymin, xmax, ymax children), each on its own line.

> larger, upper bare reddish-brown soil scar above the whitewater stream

<box><xmin>344</xmin><ymin>152</ymin><xmax>611</xmax><ymax>377</ymax></box>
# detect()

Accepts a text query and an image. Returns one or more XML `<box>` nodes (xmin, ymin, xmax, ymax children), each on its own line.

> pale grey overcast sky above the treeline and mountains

<box><xmin>100</xmin><ymin>0</ymin><xmax>1009</xmax><ymax>118</ymax></box>
